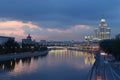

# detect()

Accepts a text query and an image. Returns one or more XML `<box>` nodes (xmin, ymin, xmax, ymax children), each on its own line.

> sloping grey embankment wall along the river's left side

<box><xmin>0</xmin><ymin>50</ymin><xmax>48</xmax><ymax>61</ymax></box>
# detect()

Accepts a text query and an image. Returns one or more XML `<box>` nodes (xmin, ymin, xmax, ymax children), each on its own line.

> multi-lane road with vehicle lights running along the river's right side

<box><xmin>88</xmin><ymin>52</ymin><xmax>120</xmax><ymax>80</ymax></box>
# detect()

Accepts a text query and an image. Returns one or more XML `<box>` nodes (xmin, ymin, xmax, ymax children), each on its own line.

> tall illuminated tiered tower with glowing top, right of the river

<box><xmin>94</xmin><ymin>18</ymin><xmax>111</xmax><ymax>41</ymax></box>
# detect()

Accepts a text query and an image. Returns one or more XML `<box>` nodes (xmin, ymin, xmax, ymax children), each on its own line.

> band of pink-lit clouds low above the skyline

<box><xmin>0</xmin><ymin>21</ymin><xmax>93</xmax><ymax>41</ymax></box>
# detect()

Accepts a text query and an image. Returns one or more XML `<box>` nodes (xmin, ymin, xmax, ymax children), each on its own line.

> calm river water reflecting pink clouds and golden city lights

<box><xmin>0</xmin><ymin>50</ymin><xmax>95</xmax><ymax>80</ymax></box>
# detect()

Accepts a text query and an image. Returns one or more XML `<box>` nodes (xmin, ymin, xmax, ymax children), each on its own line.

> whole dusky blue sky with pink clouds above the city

<box><xmin>0</xmin><ymin>0</ymin><xmax>120</xmax><ymax>41</ymax></box>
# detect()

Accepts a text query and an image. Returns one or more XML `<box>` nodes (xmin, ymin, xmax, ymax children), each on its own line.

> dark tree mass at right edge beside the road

<box><xmin>99</xmin><ymin>39</ymin><xmax>120</xmax><ymax>60</ymax></box>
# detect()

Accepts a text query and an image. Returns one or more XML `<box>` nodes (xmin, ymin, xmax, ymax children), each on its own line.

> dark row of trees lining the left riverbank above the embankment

<box><xmin>0</xmin><ymin>38</ymin><xmax>47</xmax><ymax>54</ymax></box>
